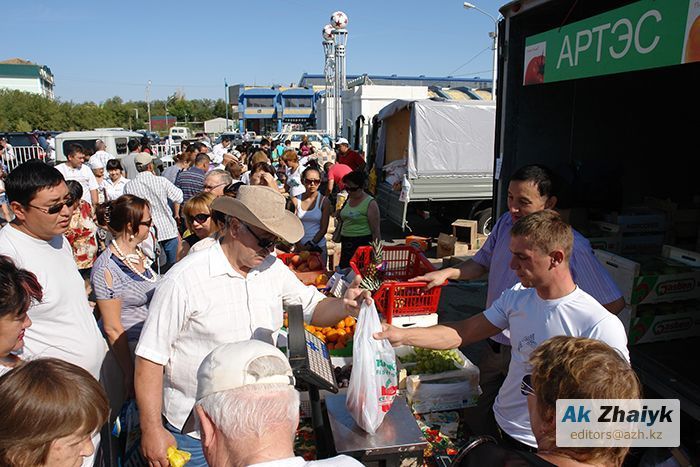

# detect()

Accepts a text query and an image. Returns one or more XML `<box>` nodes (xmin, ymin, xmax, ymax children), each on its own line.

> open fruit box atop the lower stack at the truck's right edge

<box><xmin>594</xmin><ymin>245</ymin><xmax>700</xmax><ymax>305</ymax></box>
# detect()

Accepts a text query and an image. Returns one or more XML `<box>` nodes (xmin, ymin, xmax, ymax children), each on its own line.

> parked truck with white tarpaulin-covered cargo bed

<box><xmin>368</xmin><ymin>99</ymin><xmax>496</xmax><ymax>233</ymax></box>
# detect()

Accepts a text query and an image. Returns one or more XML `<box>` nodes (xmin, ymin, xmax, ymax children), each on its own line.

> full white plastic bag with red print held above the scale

<box><xmin>346</xmin><ymin>302</ymin><xmax>398</xmax><ymax>434</ymax></box>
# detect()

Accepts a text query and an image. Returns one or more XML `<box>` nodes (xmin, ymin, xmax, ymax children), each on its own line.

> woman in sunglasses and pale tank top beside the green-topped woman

<box><xmin>292</xmin><ymin>167</ymin><xmax>331</xmax><ymax>264</ymax></box>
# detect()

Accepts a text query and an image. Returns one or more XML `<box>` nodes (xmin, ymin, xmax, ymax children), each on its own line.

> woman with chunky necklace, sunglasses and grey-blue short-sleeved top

<box><xmin>91</xmin><ymin>195</ymin><xmax>159</xmax><ymax>395</ymax></box>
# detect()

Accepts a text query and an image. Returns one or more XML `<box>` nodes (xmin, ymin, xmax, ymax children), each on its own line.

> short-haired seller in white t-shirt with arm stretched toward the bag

<box><xmin>375</xmin><ymin>210</ymin><xmax>629</xmax><ymax>449</ymax></box>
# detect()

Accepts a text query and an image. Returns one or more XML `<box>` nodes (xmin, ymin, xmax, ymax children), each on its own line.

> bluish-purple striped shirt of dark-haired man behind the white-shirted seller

<box><xmin>472</xmin><ymin>212</ymin><xmax>622</xmax><ymax>345</ymax></box>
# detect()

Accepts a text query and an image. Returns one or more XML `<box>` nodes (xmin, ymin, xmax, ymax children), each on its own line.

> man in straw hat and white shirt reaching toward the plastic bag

<box><xmin>135</xmin><ymin>186</ymin><xmax>369</xmax><ymax>466</ymax></box>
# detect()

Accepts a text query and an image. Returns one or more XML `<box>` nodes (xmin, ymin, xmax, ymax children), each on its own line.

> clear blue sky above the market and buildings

<box><xmin>0</xmin><ymin>0</ymin><xmax>505</xmax><ymax>102</ymax></box>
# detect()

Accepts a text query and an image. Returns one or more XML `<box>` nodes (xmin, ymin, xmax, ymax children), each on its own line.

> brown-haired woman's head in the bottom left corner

<box><xmin>0</xmin><ymin>358</ymin><xmax>109</xmax><ymax>467</ymax></box>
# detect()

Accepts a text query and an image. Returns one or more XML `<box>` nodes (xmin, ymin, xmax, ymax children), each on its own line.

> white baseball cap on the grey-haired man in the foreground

<box><xmin>182</xmin><ymin>340</ymin><xmax>295</xmax><ymax>433</ymax></box>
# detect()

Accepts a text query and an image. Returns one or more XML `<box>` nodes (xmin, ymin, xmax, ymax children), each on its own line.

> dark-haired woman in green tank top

<box><xmin>339</xmin><ymin>170</ymin><xmax>382</xmax><ymax>268</ymax></box>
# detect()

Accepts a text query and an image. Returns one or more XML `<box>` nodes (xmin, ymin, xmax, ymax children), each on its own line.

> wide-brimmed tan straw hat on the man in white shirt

<box><xmin>211</xmin><ymin>185</ymin><xmax>304</xmax><ymax>243</ymax></box>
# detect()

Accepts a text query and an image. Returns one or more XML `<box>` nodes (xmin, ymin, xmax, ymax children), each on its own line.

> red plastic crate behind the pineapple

<box><xmin>350</xmin><ymin>245</ymin><xmax>444</xmax><ymax>324</ymax></box>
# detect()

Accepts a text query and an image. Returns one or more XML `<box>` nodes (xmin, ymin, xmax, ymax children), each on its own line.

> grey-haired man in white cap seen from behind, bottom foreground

<box><xmin>188</xmin><ymin>340</ymin><xmax>362</xmax><ymax>467</ymax></box>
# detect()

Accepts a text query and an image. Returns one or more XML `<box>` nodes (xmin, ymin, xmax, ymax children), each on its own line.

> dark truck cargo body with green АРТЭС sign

<box><xmin>493</xmin><ymin>0</ymin><xmax>700</xmax><ymax>465</ymax></box>
